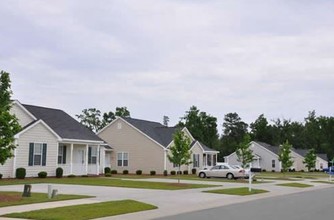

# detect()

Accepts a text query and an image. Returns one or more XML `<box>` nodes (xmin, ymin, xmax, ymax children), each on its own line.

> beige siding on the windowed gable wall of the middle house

<box><xmin>99</xmin><ymin>119</ymin><xmax>164</xmax><ymax>174</ymax></box>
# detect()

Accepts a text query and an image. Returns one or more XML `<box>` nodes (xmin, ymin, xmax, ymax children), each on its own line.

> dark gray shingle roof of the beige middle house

<box><xmin>123</xmin><ymin>117</ymin><xmax>178</xmax><ymax>147</ymax></box>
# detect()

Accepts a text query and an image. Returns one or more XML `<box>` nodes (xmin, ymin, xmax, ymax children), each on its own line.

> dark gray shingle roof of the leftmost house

<box><xmin>22</xmin><ymin>104</ymin><xmax>103</xmax><ymax>141</ymax></box>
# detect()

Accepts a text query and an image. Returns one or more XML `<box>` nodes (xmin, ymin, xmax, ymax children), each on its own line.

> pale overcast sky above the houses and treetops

<box><xmin>0</xmin><ymin>0</ymin><xmax>334</xmax><ymax>132</ymax></box>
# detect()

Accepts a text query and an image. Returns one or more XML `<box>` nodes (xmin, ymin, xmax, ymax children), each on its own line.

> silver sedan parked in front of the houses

<box><xmin>198</xmin><ymin>164</ymin><xmax>246</xmax><ymax>179</ymax></box>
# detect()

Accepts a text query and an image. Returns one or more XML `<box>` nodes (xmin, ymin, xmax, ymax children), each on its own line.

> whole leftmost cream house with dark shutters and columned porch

<box><xmin>0</xmin><ymin>101</ymin><xmax>105</xmax><ymax>178</ymax></box>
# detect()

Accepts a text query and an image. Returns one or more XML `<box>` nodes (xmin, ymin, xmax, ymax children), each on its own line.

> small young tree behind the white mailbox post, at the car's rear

<box><xmin>236</xmin><ymin>134</ymin><xmax>254</xmax><ymax>168</ymax></box>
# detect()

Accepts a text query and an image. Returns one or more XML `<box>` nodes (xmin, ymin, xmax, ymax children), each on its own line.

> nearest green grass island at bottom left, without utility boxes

<box><xmin>4</xmin><ymin>200</ymin><xmax>157</xmax><ymax>220</ymax></box>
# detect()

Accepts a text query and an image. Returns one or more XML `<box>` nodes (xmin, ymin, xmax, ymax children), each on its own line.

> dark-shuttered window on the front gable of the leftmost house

<box><xmin>28</xmin><ymin>143</ymin><xmax>47</xmax><ymax>166</ymax></box>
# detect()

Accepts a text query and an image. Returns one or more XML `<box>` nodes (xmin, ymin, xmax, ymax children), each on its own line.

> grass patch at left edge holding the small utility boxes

<box><xmin>0</xmin><ymin>191</ymin><xmax>92</xmax><ymax>207</ymax></box>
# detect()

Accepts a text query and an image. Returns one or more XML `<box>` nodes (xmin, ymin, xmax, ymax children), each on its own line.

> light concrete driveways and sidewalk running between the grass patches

<box><xmin>0</xmin><ymin>178</ymin><xmax>333</xmax><ymax>220</ymax></box>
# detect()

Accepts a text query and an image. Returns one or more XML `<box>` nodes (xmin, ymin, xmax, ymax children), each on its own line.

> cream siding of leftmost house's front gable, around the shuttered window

<box><xmin>16</xmin><ymin>124</ymin><xmax>58</xmax><ymax>177</ymax></box>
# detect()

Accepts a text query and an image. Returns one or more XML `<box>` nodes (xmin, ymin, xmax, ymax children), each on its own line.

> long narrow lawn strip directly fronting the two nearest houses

<box><xmin>0</xmin><ymin>177</ymin><xmax>213</xmax><ymax>190</ymax></box>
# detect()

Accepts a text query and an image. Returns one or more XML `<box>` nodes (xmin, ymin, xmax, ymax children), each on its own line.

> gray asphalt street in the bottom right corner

<box><xmin>157</xmin><ymin>187</ymin><xmax>334</xmax><ymax>220</ymax></box>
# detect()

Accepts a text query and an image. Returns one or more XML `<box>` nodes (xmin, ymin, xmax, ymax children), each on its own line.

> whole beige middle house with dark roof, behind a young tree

<box><xmin>98</xmin><ymin>117</ymin><xmax>218</xmax><ymax>174</ymax></box>
